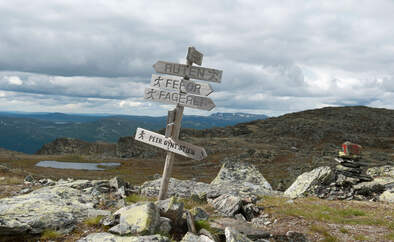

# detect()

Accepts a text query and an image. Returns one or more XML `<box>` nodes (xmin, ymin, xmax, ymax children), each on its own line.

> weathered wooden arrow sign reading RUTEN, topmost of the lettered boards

<box><xmin>153</xmin><ymin>61</ymin><xmax>223</xmax><ymax>83</ymax></box>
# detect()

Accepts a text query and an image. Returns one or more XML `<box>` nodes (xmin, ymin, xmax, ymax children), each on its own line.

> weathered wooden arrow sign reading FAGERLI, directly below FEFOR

<box><xmin>144</xmin><ymin>87</ymin><xmax>215</xmax><ymax>110</ymax></box>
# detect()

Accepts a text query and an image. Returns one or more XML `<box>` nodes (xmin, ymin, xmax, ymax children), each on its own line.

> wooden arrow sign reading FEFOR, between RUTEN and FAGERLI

<box><xmin>150</xmin><ymin>74</ymin><xmax>213</xmax><ymax>96</ymax></box>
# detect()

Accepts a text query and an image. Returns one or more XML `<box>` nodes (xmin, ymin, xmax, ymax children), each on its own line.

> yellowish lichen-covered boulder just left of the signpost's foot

<box><xmin>110</xmin><ymin>202</ymin><xmax>160</xmax><ymax>235</ymax></box>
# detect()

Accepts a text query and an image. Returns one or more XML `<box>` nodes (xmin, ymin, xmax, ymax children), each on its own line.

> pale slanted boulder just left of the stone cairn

<box><xmin>284</xmin><ymin>166</ymin><xmax>335</xmax><ymax>198</ymax></box>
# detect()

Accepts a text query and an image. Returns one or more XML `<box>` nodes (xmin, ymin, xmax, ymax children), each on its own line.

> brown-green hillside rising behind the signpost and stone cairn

<box><xmin>35</xmin><ymin>107</ymin><xmax>394</xmax><ymax>187</ymax></box>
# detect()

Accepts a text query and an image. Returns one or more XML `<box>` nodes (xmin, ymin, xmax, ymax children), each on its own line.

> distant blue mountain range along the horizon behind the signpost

<box><xmin>0</xmin><ymin>112</ymin><xmax>267</xmax><ymax>153</ymax></box>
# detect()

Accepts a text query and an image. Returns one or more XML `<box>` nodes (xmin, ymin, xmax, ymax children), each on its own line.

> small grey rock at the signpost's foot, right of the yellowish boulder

<box><xmin>155</xmin><ymin>197</ymin><xmax>183</xmax><ymax>224</ymax></box>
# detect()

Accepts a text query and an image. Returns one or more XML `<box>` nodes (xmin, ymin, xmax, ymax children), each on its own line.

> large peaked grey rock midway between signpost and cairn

<box><xmin>211</xmin><ymin>160</ymin><xmax>272</xmax><ymax>190</ymax></box>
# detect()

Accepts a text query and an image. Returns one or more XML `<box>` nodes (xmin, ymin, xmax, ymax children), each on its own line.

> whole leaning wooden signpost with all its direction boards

<box><xmin>135</xmin><ymin>47</ymin><xmax>223</xmax><ymax>200</ymax></box>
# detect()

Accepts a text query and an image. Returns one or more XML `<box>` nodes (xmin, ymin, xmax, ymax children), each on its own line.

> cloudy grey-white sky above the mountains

<box><xmin>0</xmin><ymin>0</ymin><xmax>394</xmax><ymax>116</ymax></box>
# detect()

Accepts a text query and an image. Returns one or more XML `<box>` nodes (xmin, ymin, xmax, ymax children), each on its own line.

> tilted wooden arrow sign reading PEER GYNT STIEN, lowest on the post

<box><xmin>135</xmin><ymin>128</ymin><xmax>207</xmax><ymax>160</ymax></box>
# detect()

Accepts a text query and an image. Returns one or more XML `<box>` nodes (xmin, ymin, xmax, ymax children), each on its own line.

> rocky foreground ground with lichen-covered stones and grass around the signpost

<box><xmin>0</xmin><ymin>160</ymin><xmax>394</xmax><ymax>242</ymax></box>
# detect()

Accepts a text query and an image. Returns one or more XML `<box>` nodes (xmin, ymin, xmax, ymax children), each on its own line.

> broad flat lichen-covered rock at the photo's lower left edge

<box><xmin>0</xmin><ymin>186</ymin><xmax>104</xmax><ymax>234</ymax></box>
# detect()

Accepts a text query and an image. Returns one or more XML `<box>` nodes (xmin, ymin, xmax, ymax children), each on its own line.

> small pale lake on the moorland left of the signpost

<box><xmin>36</xmin><ymin>160</ymin><xmax>120</xmax><ymax>171</ymax></box>
